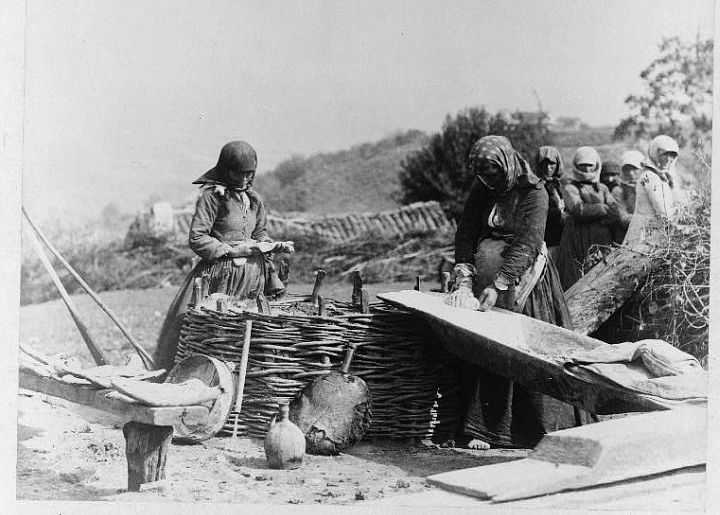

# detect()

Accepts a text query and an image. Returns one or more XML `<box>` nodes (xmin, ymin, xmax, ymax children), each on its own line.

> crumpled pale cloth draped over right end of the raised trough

<box><xmin>568</xmin><ymin>339</ymin><xmax>707</xmax><ymax>400</ymax></box>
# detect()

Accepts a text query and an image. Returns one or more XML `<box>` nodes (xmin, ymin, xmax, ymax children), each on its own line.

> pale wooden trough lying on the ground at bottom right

<box><xmin>428</xmin><ymin>407</ymin><xmax>707</xmax><ymax>502</ymax></box>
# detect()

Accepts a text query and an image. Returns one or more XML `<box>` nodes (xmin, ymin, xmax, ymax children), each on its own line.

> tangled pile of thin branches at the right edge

<box><xmin>614</xmin><ymin>188</ymin><xmax>710</xmax><ymax>367</ymax></box>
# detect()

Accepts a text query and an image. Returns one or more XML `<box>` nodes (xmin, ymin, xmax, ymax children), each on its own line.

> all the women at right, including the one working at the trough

<box><xmin>446</xmin><ymin>136</ymin><xmax>679</xmax><ymax>449</ymax></box>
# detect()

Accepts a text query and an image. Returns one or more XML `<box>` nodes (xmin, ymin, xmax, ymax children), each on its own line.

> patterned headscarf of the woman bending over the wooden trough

<box><xmin>469</xmin><ymin>136</ymin><xmax>540</xmax><ymax>194</ymax></box>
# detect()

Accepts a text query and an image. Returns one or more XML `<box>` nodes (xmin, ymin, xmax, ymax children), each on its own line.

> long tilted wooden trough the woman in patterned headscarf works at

<box><xmin>377</xmin><ymin>290</ymin><xmax>675</xmax><ymax>415</ymax></box>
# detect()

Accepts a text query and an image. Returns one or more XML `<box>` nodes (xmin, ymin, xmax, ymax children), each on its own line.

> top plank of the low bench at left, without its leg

<box><xmin>19</xmin><ymin>370</ymin><xmax>209</xmax><ymax>426</ymax></box>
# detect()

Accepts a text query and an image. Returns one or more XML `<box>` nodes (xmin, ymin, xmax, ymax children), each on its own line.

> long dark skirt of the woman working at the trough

<box><xmin>460</xmin><ymin>259</ymin><xmax>589</xmax><ymax>448</ymax></box>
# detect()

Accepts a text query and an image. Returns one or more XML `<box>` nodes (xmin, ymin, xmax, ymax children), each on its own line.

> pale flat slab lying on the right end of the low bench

<box><xmin>112</xmin><ymin>379</ymin><xmax>220</xmax><ymax>406</ymax></box>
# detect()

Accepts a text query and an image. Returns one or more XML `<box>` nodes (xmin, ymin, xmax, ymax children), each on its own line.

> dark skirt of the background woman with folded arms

<box><xmin>555</xmin><ymin>218</ymin><xmax>614</xmax><ymax>291</ymax></box>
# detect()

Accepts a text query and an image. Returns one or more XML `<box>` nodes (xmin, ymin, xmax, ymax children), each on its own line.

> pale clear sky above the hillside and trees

<box><xmin>24</xmin><ymin>0</ymin><xmax>714</xmax><ymax>220</ymax></box>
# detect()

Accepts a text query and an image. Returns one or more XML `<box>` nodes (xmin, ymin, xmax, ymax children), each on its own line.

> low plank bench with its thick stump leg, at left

<box><xmin>19</xmin><ymin>369</ymin><xmax>210</xmax><ymax>491</ymax></box>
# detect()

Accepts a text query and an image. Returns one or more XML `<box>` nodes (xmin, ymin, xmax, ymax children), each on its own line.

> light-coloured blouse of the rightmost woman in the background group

<box><xmin>623</xmin><ymin>168</ymin><xmax>675</xmax><ymax>247</ymax></box>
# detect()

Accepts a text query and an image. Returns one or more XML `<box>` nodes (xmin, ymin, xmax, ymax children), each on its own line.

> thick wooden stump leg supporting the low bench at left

<box><xmin>123</xmin><ymin>422</ymin><xmax>173</xmax><ymax>492</ymax></box>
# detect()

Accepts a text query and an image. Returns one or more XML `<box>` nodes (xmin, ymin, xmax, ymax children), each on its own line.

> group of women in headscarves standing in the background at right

<box><xmin>535</xmin><ymin>136</ymin><xmax>679</xmax><ymax>290</ymax></box>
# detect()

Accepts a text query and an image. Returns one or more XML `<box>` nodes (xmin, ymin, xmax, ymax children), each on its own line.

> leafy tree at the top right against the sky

<box><xmin>615</xmin><ymin>36</ymin><xmax>713</xmax><ymax>145</ymax></box>
